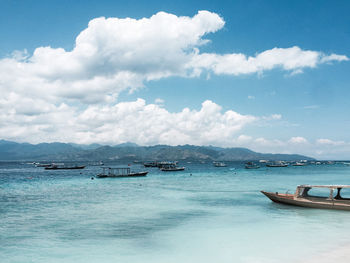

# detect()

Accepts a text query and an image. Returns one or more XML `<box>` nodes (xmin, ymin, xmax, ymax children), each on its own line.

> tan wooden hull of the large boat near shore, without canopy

<box><xmin>261</xmin><ymin>191</ymin><xmax>350</xmax><ymax>211</ymax></box>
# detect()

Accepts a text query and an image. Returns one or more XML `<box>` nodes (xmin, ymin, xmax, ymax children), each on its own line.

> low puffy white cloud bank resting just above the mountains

<box><xmin>0</xmin><ymin>99</ymin><xmax>257</xmax><ymax>146</ymax></box>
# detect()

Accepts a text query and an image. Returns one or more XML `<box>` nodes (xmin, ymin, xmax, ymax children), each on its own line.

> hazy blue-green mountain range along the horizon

<box><xmin>0</xmin><ymin>140</ymin><xmax>313</xmax><ymax>161</ymax></box>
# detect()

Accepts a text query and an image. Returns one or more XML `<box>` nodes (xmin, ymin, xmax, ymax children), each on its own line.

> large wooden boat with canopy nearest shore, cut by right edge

<box><xmin>261</xmin><ymin>185</ymin><xmax>350</xmax><ymax>211</ymax></box>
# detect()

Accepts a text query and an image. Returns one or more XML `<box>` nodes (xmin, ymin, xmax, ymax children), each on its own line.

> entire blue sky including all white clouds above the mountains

<box><xmin>0</xmin><ymin>0</ymin><xmax>350</xmax><ymax>160</ymax></box>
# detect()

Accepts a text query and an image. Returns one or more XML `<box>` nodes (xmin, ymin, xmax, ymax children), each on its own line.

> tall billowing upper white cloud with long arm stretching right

<box><xmin>0</xmin><ymin>11</ymin><xmax>348</xmax><ymax>109</ymax></box>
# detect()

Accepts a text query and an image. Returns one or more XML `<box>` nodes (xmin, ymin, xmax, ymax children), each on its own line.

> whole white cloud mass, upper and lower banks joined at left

<box><xmin>0</xmin><ymin>11</ymin><xmax>348</xmax><ymax>152</ymax></box>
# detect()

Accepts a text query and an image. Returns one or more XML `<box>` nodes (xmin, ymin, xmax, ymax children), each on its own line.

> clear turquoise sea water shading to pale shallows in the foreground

<box><xmin>0</xmin><ymin>162</ymin><xmax>350</xmax><ymax>263</ymax></box>
